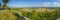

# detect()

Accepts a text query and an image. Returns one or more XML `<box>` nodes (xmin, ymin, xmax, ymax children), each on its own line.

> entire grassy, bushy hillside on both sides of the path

<box><xmin>0</xmin><ymin>8</ymin><xmax>60</xmax><ymax>20</ymax></box>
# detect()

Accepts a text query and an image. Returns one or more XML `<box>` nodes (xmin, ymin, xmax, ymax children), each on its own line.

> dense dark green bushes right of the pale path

<box><xmin>21</xmin><ymin>10</ymin><xmax>60</xmax><ymax>20</ymax></box>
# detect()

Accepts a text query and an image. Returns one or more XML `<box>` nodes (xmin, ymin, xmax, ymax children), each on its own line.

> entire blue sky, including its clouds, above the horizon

<box><xmin>0</xmin><ymin>0</ymin><xmax>60</xmax><ymax>7</ymax></box>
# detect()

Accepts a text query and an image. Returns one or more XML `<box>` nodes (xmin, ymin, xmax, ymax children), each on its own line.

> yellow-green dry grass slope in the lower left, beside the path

<box><xmin>0</xmin><ymin>10</ymin><xmax>16</xmax><ymax>20</ymax></box>
